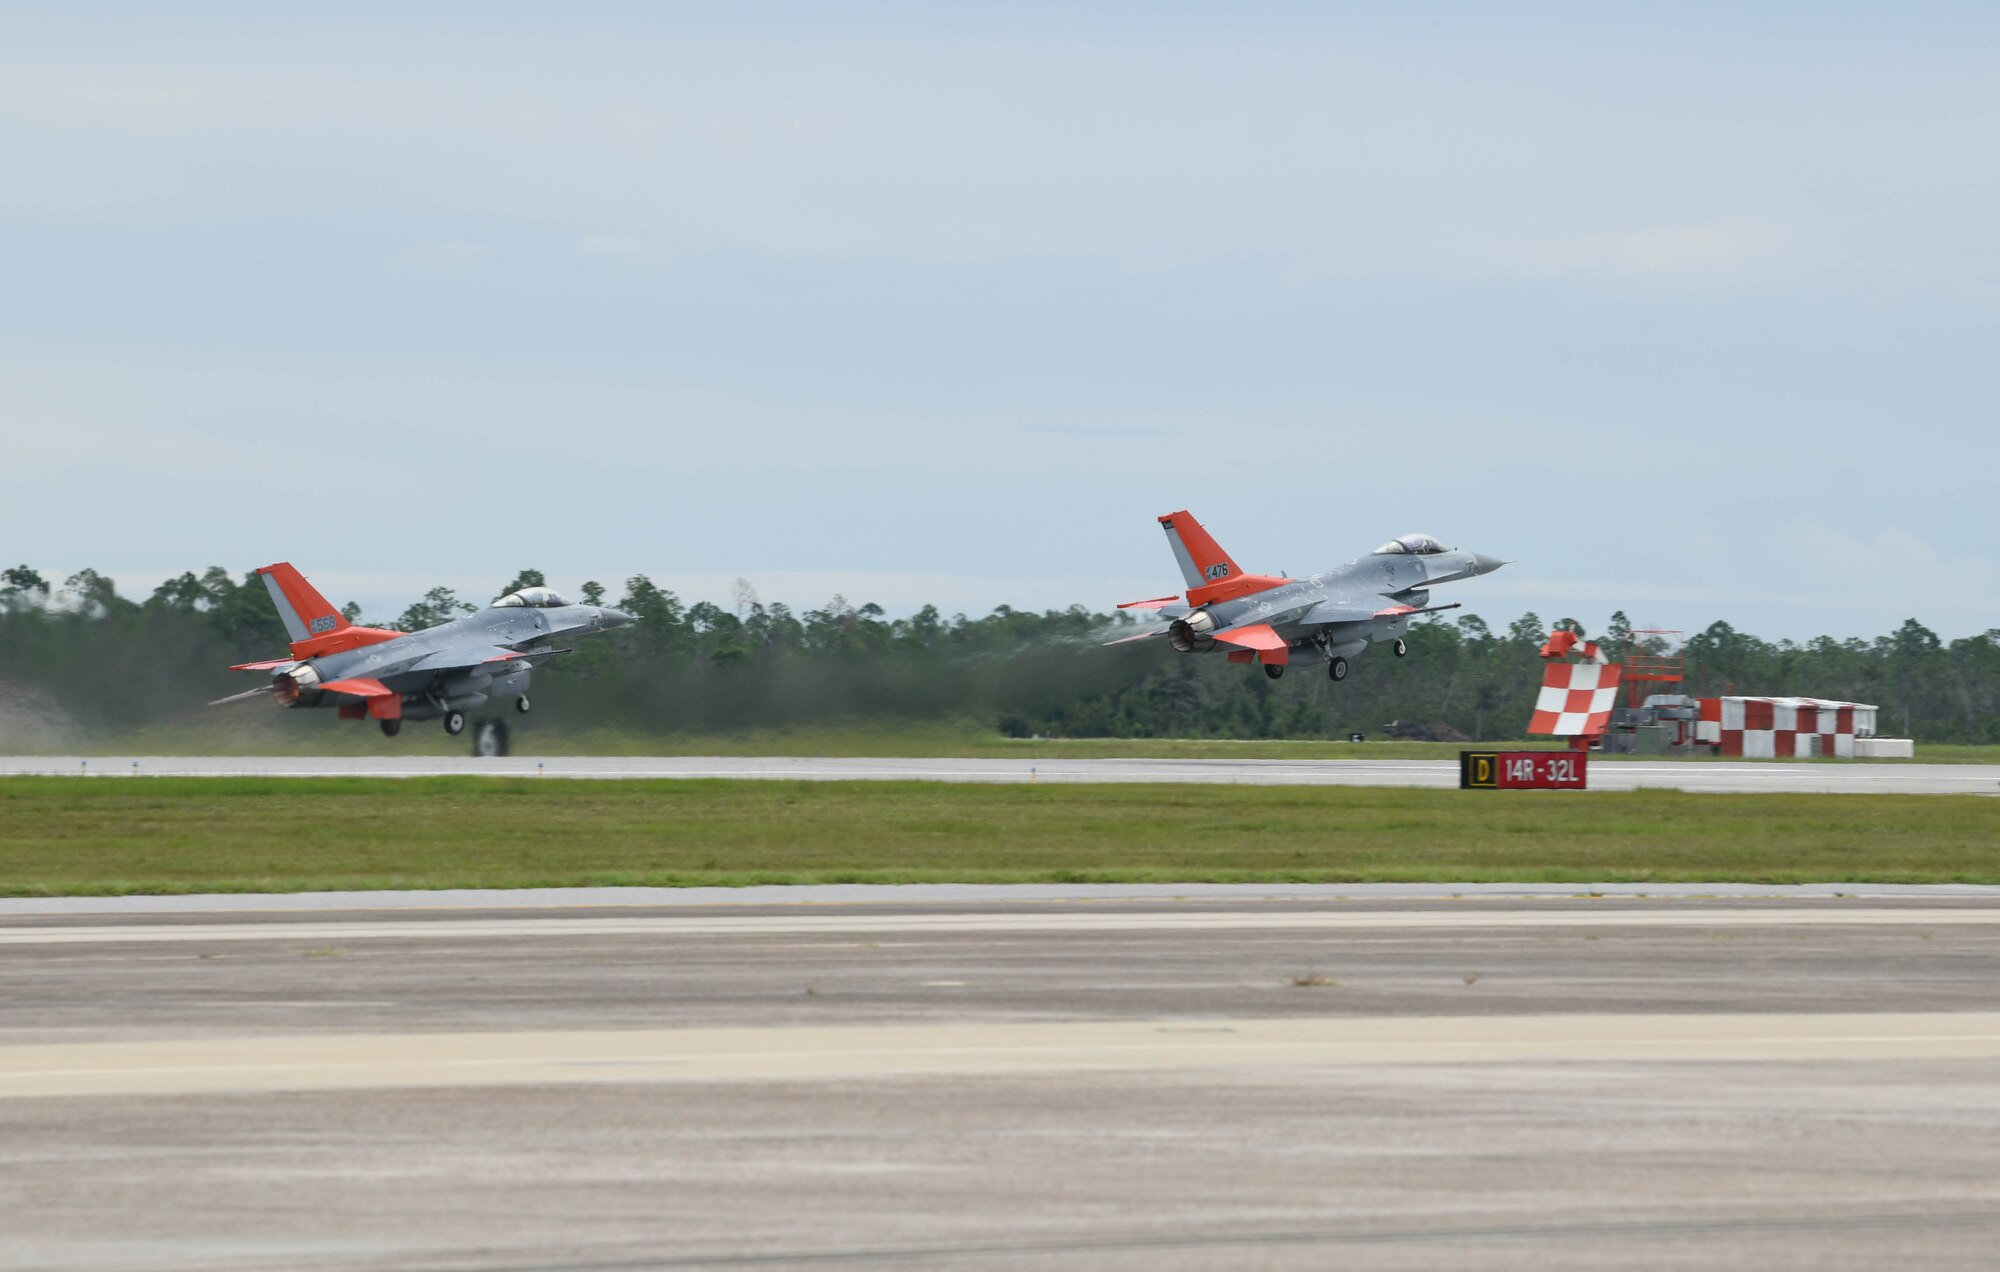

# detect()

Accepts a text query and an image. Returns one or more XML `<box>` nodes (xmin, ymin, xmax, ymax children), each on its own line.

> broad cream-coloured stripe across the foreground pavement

<box><xmin>0</xmin><ymin>1012</ymin><xmax>2000</xmax><ymax>1098</ymax></box>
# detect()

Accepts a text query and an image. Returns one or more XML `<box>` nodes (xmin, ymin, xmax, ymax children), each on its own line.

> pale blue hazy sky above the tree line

<box><xmin>0</xmin><ymin>2</ymin><xmax>2000</xmax><ymax>640</ymax></box>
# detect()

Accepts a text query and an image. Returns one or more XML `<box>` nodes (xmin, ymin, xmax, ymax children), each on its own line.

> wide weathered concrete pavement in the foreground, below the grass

<box><xmin>0</xmin><ymin>886</ymin><xmax>2000</xmax><ymax>1272</ymax></box>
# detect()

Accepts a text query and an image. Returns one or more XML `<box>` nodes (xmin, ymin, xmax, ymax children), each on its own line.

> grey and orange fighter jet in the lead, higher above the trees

<box><xmin>1110</xmin><ymin>512</ymin><xmax>1506</xmax><ymax>680</ymax></box>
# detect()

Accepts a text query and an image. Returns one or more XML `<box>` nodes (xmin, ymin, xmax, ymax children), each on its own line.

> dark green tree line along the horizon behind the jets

<box><xmin>0</xmin><ymin>566</ymin><xmax>2000</xmax><ymax>742</ymax></box>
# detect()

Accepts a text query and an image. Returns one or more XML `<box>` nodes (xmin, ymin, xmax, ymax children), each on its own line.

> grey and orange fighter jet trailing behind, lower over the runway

<box><xmin>210</xmin><ymin>562</ymin><xmax>632</xmax><ymax>754</ymax></box>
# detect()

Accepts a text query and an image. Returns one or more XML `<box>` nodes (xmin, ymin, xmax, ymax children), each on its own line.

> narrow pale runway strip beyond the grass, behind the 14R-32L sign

<box><xmin>0</xmin><ymin>756</ymin><xmax>2000</xmax><ymax>796</ymax></box>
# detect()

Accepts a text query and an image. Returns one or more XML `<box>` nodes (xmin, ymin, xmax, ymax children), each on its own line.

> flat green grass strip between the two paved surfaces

<box><xmin>0</xmin><ymin>778</ymin><xmax>2000</xmax><ymax>896</ymax></box>
